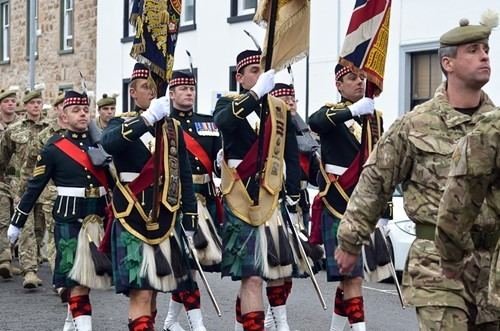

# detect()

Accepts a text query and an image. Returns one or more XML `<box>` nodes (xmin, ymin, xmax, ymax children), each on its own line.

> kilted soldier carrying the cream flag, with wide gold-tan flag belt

<box><xmin>214</xmin><ymin>50</ymin><xmax>300</xmax><ymax>330</ymax></box>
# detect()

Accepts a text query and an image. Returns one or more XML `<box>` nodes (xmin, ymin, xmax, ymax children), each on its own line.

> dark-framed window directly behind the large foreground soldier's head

<box><xmin>410</xmin><ymin>50</ymin><xmax>442</xmax><ymax>109</ymax></box>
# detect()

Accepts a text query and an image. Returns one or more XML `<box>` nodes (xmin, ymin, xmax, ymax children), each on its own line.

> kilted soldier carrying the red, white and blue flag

<box><xmin>309</xmin><ymin>64</ymin><xmax>382</xmax><ymax>331</ymax></box>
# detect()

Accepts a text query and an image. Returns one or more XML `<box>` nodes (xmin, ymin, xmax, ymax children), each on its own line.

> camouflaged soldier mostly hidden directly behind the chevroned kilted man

<box><xmin>18</xmin><ymin>93</ymin><xmax>65</xmax><ymax>278</ymax></box>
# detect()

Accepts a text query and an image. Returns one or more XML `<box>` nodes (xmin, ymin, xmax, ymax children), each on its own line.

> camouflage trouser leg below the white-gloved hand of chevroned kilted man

<box><xmin>19</xmin><ymin>203</ymin><xmax>45</xmax><ymax>274</ymax></box>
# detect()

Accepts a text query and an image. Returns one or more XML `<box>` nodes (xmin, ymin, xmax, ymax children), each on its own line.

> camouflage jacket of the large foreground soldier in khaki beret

<box><xmin>338</xmin><ymin>82</ymin><xmax>494</xmax><ymax>254</ymax></box>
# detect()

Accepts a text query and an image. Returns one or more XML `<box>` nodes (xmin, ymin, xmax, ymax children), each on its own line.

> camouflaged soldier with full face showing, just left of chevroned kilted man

<box><xmin>0</xmin><ymin>91</ymin><xmax>48</xmax><ymax>289</ymax></box>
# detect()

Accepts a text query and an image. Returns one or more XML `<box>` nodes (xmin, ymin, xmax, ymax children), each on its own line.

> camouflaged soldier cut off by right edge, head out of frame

<box><xmin>436</xmin><ymin>109</ymin><xmax>500</xmax><ymax>320</ymax></box>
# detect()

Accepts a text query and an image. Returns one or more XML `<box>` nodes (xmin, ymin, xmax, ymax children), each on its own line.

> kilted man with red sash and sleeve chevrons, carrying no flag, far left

<box><xmin>8</xmin><ymin>91</ymin><xmax>111</xmax><ymax>331</ymax></box>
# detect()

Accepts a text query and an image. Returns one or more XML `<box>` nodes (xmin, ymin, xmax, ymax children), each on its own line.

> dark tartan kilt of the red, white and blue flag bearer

<box><xmin>321</xmin><ymin>208</ymin><xmax>363</xmax><ymax>282</ymax></box>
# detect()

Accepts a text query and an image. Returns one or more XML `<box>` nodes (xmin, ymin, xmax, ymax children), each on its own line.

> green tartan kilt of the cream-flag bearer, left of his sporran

<box><xmin>221</xmin><ymin>205</ymin><xmax>262</xmax><ymax>281</ymax></box>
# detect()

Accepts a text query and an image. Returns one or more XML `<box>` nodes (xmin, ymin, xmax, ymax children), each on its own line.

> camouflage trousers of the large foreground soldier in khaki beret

<box><xmin>403</xmin><ymin>239</ymin><xmax>498</xmax><ymax>330</ymax></box>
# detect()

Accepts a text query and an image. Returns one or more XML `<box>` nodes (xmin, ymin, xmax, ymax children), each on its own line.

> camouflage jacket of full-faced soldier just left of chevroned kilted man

<box><xmin>0</xmin><ymin>118</ymin><xmax>48</xmax><ymax>200</ymax></box>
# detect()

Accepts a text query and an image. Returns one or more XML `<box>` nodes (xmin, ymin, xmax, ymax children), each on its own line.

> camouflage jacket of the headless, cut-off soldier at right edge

<box><xmin>436</xmin><ymin>109</ymin><xmax>500</xmax><ymax>271</ymax></box>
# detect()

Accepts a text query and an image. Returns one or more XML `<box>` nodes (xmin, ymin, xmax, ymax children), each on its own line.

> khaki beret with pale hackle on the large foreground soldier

<box><xmin>439</xmin><ymin>10</ymin><xmax>498</xmax><ymax>47</ymax></box>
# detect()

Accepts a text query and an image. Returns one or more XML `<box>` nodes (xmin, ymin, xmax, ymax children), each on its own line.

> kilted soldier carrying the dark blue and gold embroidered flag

<box><xmin>101</xmin><ymin>63</ymin><xmax>197</xmax><ymax>331</ymax></box>
